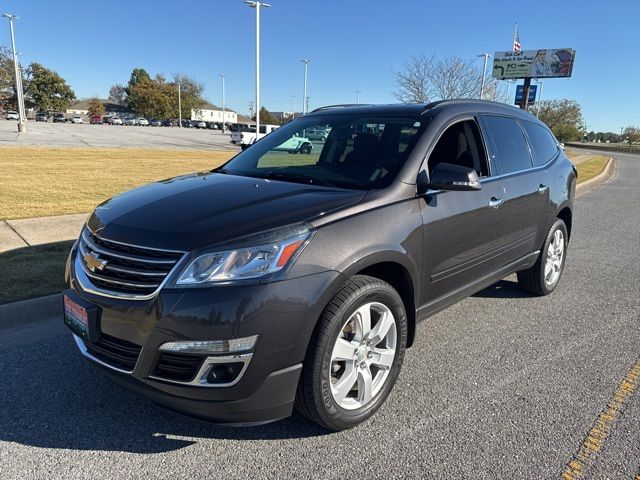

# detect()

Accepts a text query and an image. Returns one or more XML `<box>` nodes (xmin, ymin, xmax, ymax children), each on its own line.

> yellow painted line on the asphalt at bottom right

<box><xmin>562</xmin><ymin>357</ymin><xmax>640</xmax><ymax>480</ymax></box>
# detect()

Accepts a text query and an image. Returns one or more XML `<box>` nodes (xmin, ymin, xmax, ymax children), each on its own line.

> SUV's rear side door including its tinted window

<box><xmin>482</xmin><ymin>115</ymin><xmax>549</xmax><ymax>264</ymax></box>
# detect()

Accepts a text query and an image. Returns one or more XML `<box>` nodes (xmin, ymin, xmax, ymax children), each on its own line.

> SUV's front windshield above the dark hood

<box><xmin>218</xmin><ymin>114</ymin><xmax>427</xmax><ymax>190</ymax></box>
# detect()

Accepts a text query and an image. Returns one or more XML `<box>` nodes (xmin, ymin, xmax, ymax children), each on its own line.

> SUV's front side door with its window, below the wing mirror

<box><xmin>420</xmin><ymin>117</ymin><xmax>505</xmax><ymax>305</ymax></box>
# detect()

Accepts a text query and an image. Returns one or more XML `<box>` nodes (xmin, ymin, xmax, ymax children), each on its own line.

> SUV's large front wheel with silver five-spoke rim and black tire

<box><xmin>296</xmin><ymin>275</ymin><xmax>407</xmax><ymax>431</ymax></box>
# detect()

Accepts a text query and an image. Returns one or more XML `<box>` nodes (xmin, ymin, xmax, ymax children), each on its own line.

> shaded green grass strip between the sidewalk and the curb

<box><xmin>0</xmin><ymin>241</ymin><xmax>73</xmax><ymax>304</ymax></box>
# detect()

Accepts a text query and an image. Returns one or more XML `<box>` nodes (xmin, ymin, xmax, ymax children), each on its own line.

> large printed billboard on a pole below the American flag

<box><xmin>493</xmin><ymin>48</ymin><xmax>576</xmax><ymax>80</ymax></box>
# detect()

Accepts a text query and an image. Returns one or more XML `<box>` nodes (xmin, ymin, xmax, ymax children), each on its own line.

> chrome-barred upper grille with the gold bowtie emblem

<box><xmin>78</xmin><ymin>228</ymin><xmax>183</xmax><ymax>296</ymax></box>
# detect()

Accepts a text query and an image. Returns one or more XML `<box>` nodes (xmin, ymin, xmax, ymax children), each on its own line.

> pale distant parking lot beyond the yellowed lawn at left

<box><xmin>0</xmin><ymin>120</ymin><xmax>240</xmax><ymax>151</ymax></box>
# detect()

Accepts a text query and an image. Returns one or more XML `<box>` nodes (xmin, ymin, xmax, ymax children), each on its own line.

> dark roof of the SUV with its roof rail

<box><xmin>307</xmin><ymin>99</ymin><xmax>541</xmax><ymax>123</ymax></box>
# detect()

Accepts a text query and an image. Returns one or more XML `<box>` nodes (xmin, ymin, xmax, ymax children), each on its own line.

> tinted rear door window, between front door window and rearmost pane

<box><xmin>484</xmin><ymin>115</ymin><xmax>532</xmax><ymax>174</ymax></box>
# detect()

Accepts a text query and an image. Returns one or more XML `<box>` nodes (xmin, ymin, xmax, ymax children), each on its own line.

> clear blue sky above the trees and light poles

<box><xmin>0</xmin><ymin>0</ymin><xmax>640</xmax><ymax>131</ymax></box>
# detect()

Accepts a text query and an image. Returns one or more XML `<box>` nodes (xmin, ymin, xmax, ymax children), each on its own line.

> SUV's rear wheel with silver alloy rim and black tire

<box><xmin>517</xmin><ymin>218</ymin><xmax>569</xmax><ymax>296</ymax></box>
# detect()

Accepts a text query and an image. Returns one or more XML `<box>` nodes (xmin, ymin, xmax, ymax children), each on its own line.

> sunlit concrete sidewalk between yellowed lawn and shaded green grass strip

<box><xmin>0</xmin><ymin>213</ymin><xmax>87</xmax><ymax>252</ymax></box>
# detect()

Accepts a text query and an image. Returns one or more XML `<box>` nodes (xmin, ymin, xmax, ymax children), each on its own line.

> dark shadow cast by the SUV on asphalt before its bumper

<box><xmin>0</xmin><ymin>334</ymin><xmax>336</xmax><ymax>453</ymax></box>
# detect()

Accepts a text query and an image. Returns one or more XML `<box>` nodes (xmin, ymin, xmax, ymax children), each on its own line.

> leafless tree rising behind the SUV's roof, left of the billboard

<box><xmin>393</xmin><ymin>54</ymin><xmax>508</xmax><ymax>103</ymax></box>
